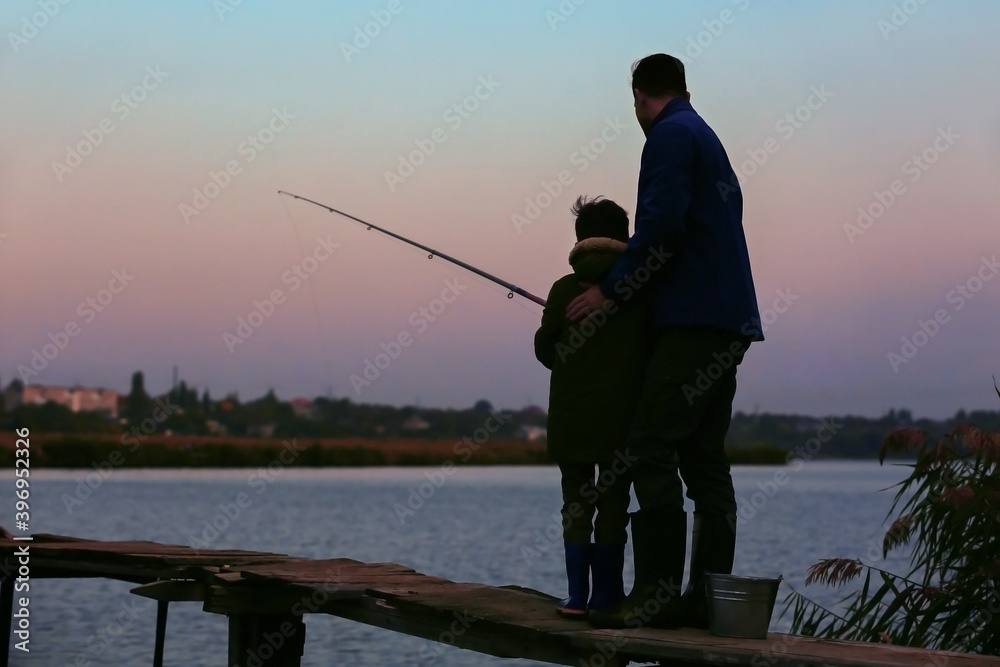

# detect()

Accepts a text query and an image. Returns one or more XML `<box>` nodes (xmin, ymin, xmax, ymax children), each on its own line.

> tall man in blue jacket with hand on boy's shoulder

<box><xmin>566</xmin><ymin>53</ymin><xmax>764</xmax><ymax>627</ymax></box>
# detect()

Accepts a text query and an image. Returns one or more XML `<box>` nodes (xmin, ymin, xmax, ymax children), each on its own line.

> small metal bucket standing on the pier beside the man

<box><xmin>705</xmin><ymin>573</ymin><xmax>781</xmax><ymax>639</ymax></box>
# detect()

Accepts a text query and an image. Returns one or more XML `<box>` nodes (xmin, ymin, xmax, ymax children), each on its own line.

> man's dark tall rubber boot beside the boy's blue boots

<box><xmin>588</xmin><ymin>506</ymin><xmax>687</xmax><ymax>628</ymax></box>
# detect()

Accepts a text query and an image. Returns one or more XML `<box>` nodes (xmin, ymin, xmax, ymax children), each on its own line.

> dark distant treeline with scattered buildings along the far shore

<box><xmin>0</xmin><ymin>372</ymin><xmax>1000</xmax><ymax>465</ymax></box>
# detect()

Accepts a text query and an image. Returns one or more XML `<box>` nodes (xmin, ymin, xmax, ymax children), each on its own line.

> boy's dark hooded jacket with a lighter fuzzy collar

<box><xmin>535</xmin><ymin>238</ymin><xmax>653</xmax><ymax>463</ymax></box>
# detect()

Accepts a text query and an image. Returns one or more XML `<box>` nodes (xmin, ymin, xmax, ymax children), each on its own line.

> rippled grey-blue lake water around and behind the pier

<box><xmin>0</xmin><ymin>461</ymin><xmax>908</xmax><ymax>667</ymax></box>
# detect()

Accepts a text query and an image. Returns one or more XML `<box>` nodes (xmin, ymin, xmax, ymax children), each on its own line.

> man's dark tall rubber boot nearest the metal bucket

<box><xmin>664</xmin><ymin>512</ymin><xmax>736</xmax><ymax>629</ymax></box>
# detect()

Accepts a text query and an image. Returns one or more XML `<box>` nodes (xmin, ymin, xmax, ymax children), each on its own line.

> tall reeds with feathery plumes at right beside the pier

<box><xmin>783</xmin><ymin>385</ymin><xmax>1000</xmax><ymax>655</ymax></box>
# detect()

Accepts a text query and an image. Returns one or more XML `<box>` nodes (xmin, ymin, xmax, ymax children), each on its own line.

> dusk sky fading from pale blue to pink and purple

<box><xmin>0</xmin><ymin>0</ymin><xmax>1000</xmax><ymax>417</ymax></box>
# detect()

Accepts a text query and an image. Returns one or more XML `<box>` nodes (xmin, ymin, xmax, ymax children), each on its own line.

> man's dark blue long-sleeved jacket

<box><xmin>601</xmin><ymin>98</ymin><xmax>764</xmax><ymax>340</ymax></box>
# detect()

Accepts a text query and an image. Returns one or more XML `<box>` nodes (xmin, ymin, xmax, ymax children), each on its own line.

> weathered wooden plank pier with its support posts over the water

<box><xmin>0</xmin><ymin>528</ymin><xmax>1000</xmax><ymax>667</ymax></box>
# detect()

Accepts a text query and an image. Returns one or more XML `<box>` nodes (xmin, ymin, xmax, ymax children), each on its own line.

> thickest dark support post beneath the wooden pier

<box><xmin>229</xmin><ymin>614</ymin><xmax>306</xmax><ymax>667</ymax></box>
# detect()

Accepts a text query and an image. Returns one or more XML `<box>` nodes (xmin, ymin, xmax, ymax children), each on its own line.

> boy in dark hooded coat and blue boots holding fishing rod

<box><xmin>535</xmin><ymin>196</ymin><xmax>652</xmax><ymax>618</ymax></box>
